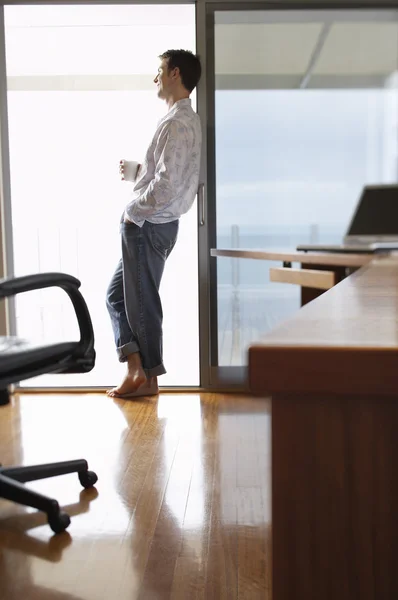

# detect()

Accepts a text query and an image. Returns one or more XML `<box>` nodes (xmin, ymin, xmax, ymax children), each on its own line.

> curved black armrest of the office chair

<box><xmin>0</xmin><ymin>273</ymin><xmax>94</xmax><ymax>356</ymax></box>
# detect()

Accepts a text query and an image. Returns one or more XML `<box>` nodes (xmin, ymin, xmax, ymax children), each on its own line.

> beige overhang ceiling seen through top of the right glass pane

<box><xmin>215</xmin><ymin>21</ymin><xmax>398</xmax><ymax>89</ymax></box>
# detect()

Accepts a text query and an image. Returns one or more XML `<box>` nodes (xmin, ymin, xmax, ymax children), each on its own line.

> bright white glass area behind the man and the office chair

<box><xmin>5</xmin><ymin>5</ymin><xmax>199</xmax><ymax>386</ymax></box>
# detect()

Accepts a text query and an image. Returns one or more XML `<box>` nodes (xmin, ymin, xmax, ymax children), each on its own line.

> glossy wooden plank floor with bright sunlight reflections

<box><xmin>0</xmin><ymin>394</ymin><xmax>271</xmax><ymax>600</ymax></box>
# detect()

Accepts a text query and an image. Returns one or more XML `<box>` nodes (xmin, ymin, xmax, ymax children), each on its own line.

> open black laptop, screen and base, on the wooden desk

<box><xmin>297</xmin><ymin>184</ymin><xmax>398</xmax><ymax>253</ymax></box>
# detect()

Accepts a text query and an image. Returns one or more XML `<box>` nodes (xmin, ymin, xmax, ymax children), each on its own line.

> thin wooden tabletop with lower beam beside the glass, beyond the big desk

<box><xmin>210</xmin><ymin>248</ymin><xmax>375</xmax><ymax>306</ymax></box>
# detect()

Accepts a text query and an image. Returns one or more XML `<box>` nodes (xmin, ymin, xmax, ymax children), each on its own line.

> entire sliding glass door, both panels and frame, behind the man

<box><xmin>0</xmin><ymin>0</ymin><xmax>398</xmax><ymax>388</ymax></box>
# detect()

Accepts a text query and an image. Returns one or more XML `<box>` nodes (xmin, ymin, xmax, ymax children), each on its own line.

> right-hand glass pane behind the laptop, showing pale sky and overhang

<box><xmin>215</xmin><ymin>11</ymin><xmax>398</xmax><ymax>366</ymax></box>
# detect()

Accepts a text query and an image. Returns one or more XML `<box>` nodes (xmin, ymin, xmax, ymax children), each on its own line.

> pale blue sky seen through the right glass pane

<box><xmin>216</xmin><ymin>90</ymin><xmax>398</xmax><ymax>237</ymax></box>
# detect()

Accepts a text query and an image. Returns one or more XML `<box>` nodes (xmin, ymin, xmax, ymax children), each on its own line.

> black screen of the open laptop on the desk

<box><xmin>346</xmin><ymin>185</ymin><xmax>398</xmax><ymax>236</ymax></box>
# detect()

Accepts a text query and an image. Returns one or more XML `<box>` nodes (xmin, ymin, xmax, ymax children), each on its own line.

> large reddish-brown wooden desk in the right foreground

<box><xmin>249</xmin><ymin>256</ymin><xmax>398</xmax><ymax>600</ymax></box>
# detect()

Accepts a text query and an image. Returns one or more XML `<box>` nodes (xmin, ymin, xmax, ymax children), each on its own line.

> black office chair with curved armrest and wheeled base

<box><xmin>0</xmin><ymin>273</ymin><xmax>98</xmax><ymax>533</ymax></box>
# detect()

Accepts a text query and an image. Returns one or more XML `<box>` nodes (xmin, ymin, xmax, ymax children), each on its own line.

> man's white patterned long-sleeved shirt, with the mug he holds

<box><xmin>124</xmin><ymin>98</ymin><xmax>202</xmax><ymax>227</ymax></box>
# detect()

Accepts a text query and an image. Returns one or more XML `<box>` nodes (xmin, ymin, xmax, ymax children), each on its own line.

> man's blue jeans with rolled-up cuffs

<box><xmin>106</xmin><ymin>220</ymin><xmax>179</xmax><ymax>377</ymax></box>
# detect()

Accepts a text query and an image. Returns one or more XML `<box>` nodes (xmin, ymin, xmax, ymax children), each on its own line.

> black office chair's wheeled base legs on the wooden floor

<box><xmin>0</xmin><ymin>460</ymin><xmax>98</xmax><ymax>533</ymax></box>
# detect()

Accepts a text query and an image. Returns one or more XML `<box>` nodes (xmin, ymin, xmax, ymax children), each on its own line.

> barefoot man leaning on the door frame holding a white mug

<box><xmin>107</xmin><ymin>50</ymin><xmax>202</xmax><ymax>398</ymax></box>
